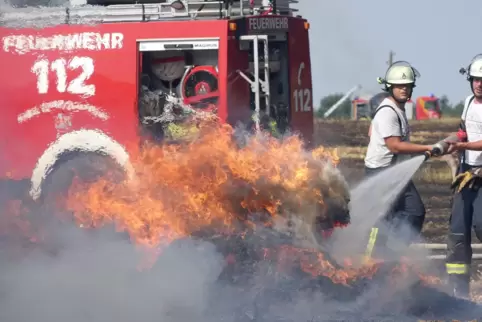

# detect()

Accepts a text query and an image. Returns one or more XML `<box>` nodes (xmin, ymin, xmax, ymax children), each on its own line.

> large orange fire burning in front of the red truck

<box><xmin>56</xmin><ymin>122</ymin><xmax>440</xmax><ymax>285</ymax></box>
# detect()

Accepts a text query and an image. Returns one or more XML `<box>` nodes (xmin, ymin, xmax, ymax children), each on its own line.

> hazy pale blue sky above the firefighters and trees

<box><xmin>293</xmin><ymin>0</ymin><xmax>482</xmax><ymax>102</ymax></box>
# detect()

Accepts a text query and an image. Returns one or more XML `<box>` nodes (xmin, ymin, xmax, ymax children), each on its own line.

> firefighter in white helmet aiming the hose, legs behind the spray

<box><xmin>365</xmin><ymin>62</ymin><xmax>440</xmax><ymax>259</ymax></box>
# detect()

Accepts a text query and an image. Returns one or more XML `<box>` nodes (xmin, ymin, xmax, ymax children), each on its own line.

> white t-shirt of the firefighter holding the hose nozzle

<box><xmin>365</xmin><ymin>98</ymin><xmax>410</xmax><ymax>168</ymax></box>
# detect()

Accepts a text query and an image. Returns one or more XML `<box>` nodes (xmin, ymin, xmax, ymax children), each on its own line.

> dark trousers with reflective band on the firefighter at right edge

<box><xmin>446</xmin><ymin>167</ymin><xmax>482</xmax><ymax>297</ymax></box>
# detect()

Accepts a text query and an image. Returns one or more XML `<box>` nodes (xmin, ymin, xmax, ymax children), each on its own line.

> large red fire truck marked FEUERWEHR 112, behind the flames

<box><xmin>0</xmin><ymin>0</ymin><xmax>313</xmax><ymax>204</ymax></box>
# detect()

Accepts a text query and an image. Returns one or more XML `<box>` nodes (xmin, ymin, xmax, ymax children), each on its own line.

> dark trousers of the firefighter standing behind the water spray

<box><xmin>365</xmin><ymin>168</ymin><xmax>425</xmax><ymax>258</ymax></box>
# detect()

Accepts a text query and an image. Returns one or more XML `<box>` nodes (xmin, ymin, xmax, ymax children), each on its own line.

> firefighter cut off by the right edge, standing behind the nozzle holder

<box><xmin>445</xmin><ymin>54</ymin><xmax>482</xmax><ymax>298</ymax></box>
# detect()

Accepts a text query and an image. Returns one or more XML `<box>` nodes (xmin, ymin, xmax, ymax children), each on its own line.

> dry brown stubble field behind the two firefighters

<box><xmin>315</xmin><ymin>119</ymin><xmax>459</xmax><ymax>243</ymax></box>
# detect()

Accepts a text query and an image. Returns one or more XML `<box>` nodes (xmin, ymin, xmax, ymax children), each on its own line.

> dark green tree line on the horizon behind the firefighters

<box><xmin>315</xmin><ymin>93</ymin><xmax>464</xmax><ymax>119</ymax></box>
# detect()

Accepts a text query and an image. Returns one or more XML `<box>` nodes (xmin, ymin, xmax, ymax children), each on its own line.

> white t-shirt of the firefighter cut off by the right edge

<box><xmin>462</xmin><ymin>95</ymin><xmax>482</xmax><ymax>166</ymax></box>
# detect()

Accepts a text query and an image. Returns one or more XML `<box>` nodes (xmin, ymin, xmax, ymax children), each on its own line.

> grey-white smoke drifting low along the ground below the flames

<box><xmin>0</xmin><ymin>155</ymin><xmax>474</xmax><ymax>322</ymax></box>
